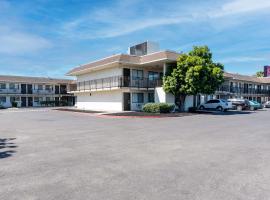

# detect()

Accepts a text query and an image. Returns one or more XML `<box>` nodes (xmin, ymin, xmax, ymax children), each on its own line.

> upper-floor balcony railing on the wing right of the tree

<box><xmin>217</xmin><ymin>85</ymin><xmax>270</xmax><ymax>95</ymax></box>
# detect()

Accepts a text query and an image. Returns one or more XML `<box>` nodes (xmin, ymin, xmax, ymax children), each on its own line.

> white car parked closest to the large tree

<box><xmin>199</xmin><ymin>99</ymin><xmax>232</xmax><ymax>112</ymax></box>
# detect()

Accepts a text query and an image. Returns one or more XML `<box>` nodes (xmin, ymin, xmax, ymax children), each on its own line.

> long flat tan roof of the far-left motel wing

<box><xmin>0</xmin><ymin>75</ymin><xmax>74</xmax><ymax>84</ymax></box>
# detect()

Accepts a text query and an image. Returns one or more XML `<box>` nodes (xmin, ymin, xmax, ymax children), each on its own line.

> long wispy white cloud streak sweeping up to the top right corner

<box><xmin>60</xmin><ymin>0</ymin><xmax>270</xmax><ymax>39</ymax></box>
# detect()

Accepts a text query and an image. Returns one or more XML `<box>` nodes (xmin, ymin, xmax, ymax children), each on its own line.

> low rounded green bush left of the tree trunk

<box><xmin>143</xmin><ymin>103</ymin><xmax>174</xmax><ymax>113</ymax></box>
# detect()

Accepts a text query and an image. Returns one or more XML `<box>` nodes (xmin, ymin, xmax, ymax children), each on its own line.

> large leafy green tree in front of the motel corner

<box><xmin>163</xmin><ymin>46</ymin><xmax>224</xmax><ymax>111</ymax></box>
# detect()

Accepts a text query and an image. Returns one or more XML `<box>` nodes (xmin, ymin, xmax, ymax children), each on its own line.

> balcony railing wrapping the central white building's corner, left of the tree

<box><xmin>72</xmin><ymin>76</ymin><xmax>162</xmax><ymax>91</ymax></box>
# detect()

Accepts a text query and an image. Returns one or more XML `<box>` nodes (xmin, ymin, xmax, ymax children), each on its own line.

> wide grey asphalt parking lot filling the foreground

<box><xmin>0</xmin><ymin>109</ymin><xmax>270</xmax><ymax>200</ymax></box>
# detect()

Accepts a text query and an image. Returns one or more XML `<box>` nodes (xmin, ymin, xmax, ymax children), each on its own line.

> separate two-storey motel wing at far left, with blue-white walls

<box><xmin>0</xmin><ymin>75</ymin><xmax>76</xmax><ymax>108</ymax></box>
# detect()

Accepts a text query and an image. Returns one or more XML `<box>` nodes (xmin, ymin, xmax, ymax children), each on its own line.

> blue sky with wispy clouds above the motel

<box><xmin>0</xmin><ymin>0</ymin><xmax>270</xmax><ymax>77</ymax></box>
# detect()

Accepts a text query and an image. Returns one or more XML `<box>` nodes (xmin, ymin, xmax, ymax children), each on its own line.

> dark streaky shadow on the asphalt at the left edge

<box><xmin>0</xmin><ymin>138</ymin><xmax>18</xmax><ymax>159</ymax></box>
